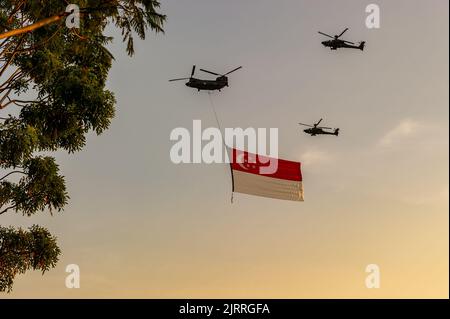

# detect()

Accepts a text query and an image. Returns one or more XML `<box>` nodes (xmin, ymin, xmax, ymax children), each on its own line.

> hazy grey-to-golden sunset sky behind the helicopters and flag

<box><xmin>2</xmin><ymin>0</ymin><xmax>449</xmax><ymax>298</ymax></box>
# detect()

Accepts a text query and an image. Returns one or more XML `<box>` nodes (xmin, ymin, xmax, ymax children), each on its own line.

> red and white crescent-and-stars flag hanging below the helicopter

<box><xmin>231</xmin><ymin>149</ymin><xmax>303</xmax><ymax>201</ymax></box>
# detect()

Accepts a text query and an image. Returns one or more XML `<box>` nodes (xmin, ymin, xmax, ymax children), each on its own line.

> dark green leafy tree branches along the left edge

<box><xmin>0</xmin><ymin>0</ymin><xmax>165</xmax><ymax>291</ymax></box>
